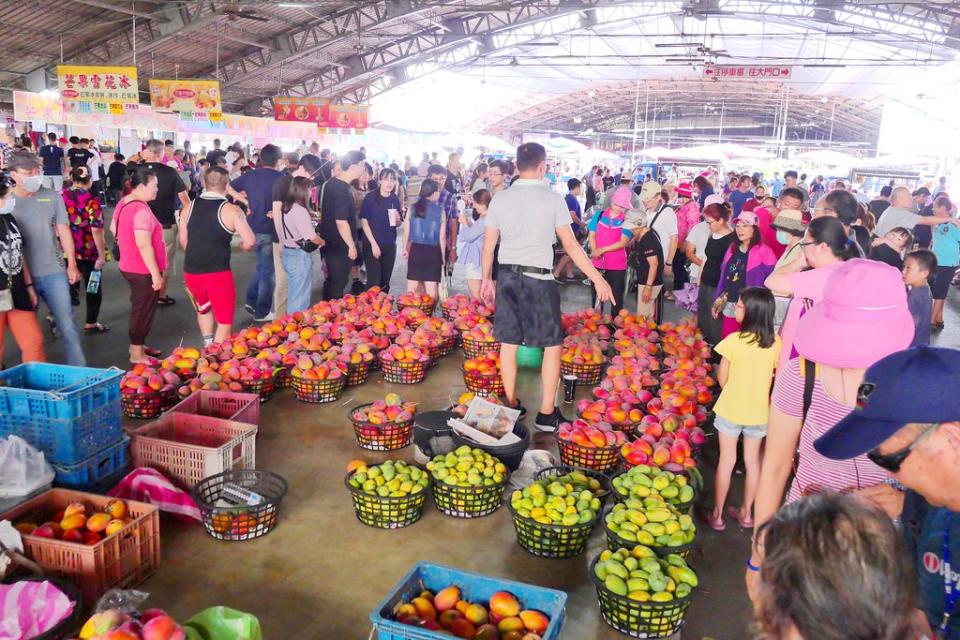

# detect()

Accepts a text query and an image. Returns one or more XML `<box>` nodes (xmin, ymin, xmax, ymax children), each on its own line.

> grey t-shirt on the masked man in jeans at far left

<box><xmin>13</xmin><ymin>189</ymin><xmax>69</xmax><ymax>278</ymax></box>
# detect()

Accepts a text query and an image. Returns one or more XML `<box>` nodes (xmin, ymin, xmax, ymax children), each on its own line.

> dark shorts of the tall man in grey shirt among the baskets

<box><xmin>493</xmin><ymin>269</ymin><xmax>563</xmax><ymax>347</ymax></box>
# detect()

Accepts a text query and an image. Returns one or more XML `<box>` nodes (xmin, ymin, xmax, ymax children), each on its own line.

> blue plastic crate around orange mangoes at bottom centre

<box><xmin>370</xmin><ymin>562</ymin><xmax>567</xmax><ymax>640</ymax></box>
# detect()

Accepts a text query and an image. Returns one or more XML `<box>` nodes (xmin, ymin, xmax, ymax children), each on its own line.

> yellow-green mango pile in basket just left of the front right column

<box><xmin>510</xmin><ymin>471</ymin><xmax>600</xmax><ymax>527</ymax></box>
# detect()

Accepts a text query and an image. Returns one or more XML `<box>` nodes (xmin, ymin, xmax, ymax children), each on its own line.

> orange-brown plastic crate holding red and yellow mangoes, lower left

<box><xmin>0</xmin><ymin>489</ymin><xmax>160</xmax><ymax>607</ymax></box>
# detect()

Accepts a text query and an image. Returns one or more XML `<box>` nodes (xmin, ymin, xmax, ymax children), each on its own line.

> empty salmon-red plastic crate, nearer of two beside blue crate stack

<box><xmin>129</xmin><ymin>410</ymin><xmax>259</xmax><ymax>489</ymax></box>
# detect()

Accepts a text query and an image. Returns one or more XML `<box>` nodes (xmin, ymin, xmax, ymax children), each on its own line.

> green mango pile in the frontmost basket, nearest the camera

<box><xmin>593</xmin><ymin>545</ymin><xmax>700</xmax><ymax>602</ymax></box>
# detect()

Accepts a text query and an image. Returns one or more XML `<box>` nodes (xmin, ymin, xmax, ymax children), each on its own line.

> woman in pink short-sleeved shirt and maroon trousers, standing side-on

<box><xmin>110</xmin><ymin>166</ymin><xmax>167</xmax><ymax>363</ymax></box>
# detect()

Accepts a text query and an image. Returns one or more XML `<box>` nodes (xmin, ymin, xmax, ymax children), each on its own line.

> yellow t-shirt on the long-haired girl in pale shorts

<box><xmin>713</xmin><ymin>331</ymin><xmax>780</xmax><ymax>425</ymax></box>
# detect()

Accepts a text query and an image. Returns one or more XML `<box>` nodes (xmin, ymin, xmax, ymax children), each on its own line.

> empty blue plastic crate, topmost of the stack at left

<box><xmin>0</xmin><ymin>362</ymin><xmax>123</xmax><ymax>420</ymax></box>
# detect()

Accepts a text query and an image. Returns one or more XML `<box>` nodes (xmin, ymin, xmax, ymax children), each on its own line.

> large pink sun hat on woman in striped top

<box><xmin>794</xmin><ymin>258</ymin><xmax>914</xmax><ymax>369</ymax></box>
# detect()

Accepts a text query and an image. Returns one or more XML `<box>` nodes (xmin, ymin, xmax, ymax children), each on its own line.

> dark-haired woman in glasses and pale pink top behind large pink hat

<box><xmin>764</xmin><ymin>217</ymin><xmax>857</xmax><ymax>371</ymax></box>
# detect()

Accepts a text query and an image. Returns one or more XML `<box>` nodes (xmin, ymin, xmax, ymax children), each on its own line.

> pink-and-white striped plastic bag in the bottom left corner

<box><xmin>0</xmin><ymin>580</ymin><xmax>77</xmax><ymax>640</ymax></box>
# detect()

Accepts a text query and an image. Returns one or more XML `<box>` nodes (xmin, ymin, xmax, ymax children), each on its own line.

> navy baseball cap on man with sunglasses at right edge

<box><xmin>813</xmin><ymin>347</ymin><xmax>960</xmax><ymax>460</ymax></box>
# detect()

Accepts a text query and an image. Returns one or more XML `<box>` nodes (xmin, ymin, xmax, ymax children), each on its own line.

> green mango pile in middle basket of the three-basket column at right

<box><xmin>605</xmin><ymin>496</ymin><xmax>697</xmax><ymax>548</ymax></box>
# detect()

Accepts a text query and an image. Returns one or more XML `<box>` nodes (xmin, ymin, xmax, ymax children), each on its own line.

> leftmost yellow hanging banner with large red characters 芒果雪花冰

<box><xmin>57</xmin><ymin>64</ymin><xmax>140</xmax><ymax>115</ymax></box>
